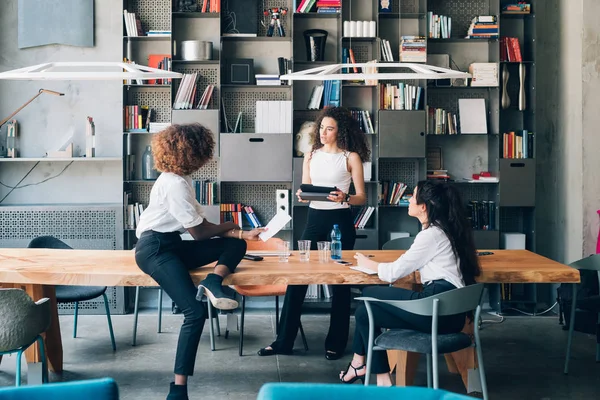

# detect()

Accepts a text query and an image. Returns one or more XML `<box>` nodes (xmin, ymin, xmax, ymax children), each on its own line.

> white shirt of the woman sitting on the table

<box><xmin>135</xmin><ymin>172</ymin><xmax>204</xmax><ymax>238</ymax></box>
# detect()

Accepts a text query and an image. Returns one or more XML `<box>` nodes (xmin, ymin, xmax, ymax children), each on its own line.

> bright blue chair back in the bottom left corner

<box><xmin>0</xmin><ymin>378</ymin><xmax>119</xmax><ymax>400</ymax></box>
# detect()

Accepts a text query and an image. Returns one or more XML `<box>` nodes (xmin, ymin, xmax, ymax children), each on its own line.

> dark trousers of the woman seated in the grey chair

<box><xmin>352</xmin><ymin>279</ymin><xmax>465</xmax><ymax>374</ymax></box>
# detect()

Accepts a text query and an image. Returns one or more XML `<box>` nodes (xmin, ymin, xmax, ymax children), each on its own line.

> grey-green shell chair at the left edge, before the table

<box><xmin>0</xmin><ymin>289</ymin><xmax>52</xmax><ymax>386</ymax></box>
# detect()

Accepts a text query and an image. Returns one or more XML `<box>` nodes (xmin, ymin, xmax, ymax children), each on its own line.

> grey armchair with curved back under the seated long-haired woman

<box><xmin>357</xmin><ymin>283</ymin><xmax>488</xmax><ymax>399</ymax></box>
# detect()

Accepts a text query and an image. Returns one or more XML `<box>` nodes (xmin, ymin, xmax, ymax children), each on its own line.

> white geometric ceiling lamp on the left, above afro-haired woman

<box><xmin>0</xmin><ymin>62</ymin><xmax>183</xmax><ymax>81</ymax></box>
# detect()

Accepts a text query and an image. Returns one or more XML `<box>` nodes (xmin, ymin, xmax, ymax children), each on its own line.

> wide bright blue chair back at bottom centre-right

<box><xmin>257</xmin><ymin>383</ymin><xmax>473</xmax><ymax>400</ymax></box>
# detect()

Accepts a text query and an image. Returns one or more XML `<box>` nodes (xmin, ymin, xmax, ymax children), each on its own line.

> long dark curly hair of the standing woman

<box><xmin>312</xmin><ymin>107</ymin><xmax>371</xmax><ymax>162</ymax></box>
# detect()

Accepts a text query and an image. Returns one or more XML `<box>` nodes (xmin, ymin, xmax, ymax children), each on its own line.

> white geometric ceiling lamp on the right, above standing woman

<box><xmin>281</xmin><ymin>62</ymin><xmax>471</xmax><ymax>81</ymax></box>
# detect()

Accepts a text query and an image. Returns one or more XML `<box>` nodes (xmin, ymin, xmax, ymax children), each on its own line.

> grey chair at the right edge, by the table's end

<box><xmin>564</xmin><ymin>254</ymin><xmax>600</xmax><ymax>374</ymax></box>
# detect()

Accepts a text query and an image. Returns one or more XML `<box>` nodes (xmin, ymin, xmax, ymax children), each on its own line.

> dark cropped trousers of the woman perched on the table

<box><xmin>135</xmin><ymin>231</ymin><xmax>246</xmax><ymax>375</ymax></box>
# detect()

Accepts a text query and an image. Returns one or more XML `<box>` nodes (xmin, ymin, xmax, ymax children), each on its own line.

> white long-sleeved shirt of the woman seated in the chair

<box><xmin>377</xmin><ymin>226</ymin><xmax>465</xmax><ymax>288</ymax></box>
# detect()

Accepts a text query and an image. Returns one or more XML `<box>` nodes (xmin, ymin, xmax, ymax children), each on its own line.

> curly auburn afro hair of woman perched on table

<box><xmin>152</xmin><ymin>124</ymin><xmax>215</xmax><ymax>176</ymax></box>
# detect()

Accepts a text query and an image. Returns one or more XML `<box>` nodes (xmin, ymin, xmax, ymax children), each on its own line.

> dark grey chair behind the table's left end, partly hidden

<box><xmin>27</xmin><ymin>236</ymin><xmax>117</xmax><ymax>351</ymax></box>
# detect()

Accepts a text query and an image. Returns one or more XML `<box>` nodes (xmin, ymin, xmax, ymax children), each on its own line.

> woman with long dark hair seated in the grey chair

<box><xmin>340</xmin><ymin>181</ymin><xmax>480</xmax><ymax>386</ymax></box>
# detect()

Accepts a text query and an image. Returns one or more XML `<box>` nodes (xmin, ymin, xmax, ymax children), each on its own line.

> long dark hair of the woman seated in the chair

<box><xmin>415</xmin><ymin>181</ymin><xmax>481</xmax><ymax>285</ymax></box>
